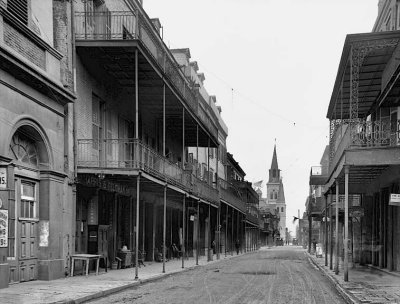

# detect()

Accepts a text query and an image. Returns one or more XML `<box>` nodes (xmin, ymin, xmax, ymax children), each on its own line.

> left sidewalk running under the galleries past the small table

<box><xmin>0</xmin><ymin>254</ymin><xmax>240</xmax><ymax>304</ymax></box>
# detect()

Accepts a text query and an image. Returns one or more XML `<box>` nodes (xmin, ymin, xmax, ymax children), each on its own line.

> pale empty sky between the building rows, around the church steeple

<box><xmin>143</xmin><ymin>0</ymin><xmax>378</xmax><ymax>235</ymax></box>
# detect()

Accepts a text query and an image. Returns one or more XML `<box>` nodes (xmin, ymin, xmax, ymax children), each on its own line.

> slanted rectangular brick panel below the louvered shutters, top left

<box><xmin>4</xmin><ymin>22</ymin><xmax>46</xmax><ymax>70</ymax></box>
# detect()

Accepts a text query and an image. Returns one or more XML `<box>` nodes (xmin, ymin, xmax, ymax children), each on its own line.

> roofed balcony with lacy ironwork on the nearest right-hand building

<box><xmin>327</xmin><ymin>31</ymin><xmax>400</xmax><ymax>191</ymax></box>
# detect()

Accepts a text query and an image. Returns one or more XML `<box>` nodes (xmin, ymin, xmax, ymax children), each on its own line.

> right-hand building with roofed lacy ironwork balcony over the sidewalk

<box><xmin>325</xmin><ymin>1</ymin><xmax>400</xmax><ymax>280</ymax></box>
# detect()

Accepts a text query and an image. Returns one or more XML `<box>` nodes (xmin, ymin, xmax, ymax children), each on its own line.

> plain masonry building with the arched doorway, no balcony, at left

<box><xmin>0</xmin><ymin>0</ymin><xmax>75</xmax><ymax>288</ymax></box>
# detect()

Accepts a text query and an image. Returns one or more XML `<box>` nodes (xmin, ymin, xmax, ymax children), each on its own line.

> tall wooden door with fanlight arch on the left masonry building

<box><xmin>8</xmin><ymin>125</ymin><xmax>49</xmax><ymax>283</ymax></box>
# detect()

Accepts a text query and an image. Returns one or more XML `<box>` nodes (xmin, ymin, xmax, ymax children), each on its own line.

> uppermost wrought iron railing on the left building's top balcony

<box><xmin>75</xmin><ymin>8</ymin><xmax>218</xmax><ymax>139</ymax></box>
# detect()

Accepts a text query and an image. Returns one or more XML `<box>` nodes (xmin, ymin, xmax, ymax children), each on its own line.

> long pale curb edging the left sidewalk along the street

<box><xmin>59</xmin><ymin>251</ymin><xmax>250</xmax><ymax>304</ymax></box>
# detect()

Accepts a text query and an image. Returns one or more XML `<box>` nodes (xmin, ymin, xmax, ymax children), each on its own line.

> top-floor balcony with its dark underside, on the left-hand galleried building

<box><xmin>75</xmin><ymin>7</ymin><xmax>218</xmax><ymax>143</ymax></box>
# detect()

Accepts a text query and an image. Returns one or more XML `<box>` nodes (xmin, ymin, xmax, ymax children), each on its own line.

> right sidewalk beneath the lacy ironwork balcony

<box><xmin>306</xmin><ymin>253</ymin><xmax>400</xmax><ymax>304</ymax></box>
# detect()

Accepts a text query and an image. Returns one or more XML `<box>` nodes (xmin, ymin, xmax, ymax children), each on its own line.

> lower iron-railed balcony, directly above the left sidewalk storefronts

<box><xmin>77</xmin><ymin>139</ymin><xmax>219</xmax><ymax>205</ymax></box>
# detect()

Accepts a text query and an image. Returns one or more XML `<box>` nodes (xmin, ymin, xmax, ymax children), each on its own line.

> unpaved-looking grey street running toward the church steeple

<box><xmin>90</xmin><ymin>246</ymin><xmax>345</xmax><ymax>304</ymax></box>
